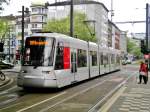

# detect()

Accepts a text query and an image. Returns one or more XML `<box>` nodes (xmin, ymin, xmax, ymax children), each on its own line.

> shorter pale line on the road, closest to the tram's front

<box><xmin>16</xmin><ymin>92</ymin><xmax>66</xmax><ymax>112</ymax></box>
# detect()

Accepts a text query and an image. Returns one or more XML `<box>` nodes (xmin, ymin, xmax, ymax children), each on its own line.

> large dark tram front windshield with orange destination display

<box><xmin>23</xmin><ymin>37</ymin><xmax>55</xmax><ymax>67</ymax></box>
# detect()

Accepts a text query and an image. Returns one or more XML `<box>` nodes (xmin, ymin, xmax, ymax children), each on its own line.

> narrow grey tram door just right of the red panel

<box><xmin>71</xmin><ymin>49</ymin><xmax>77</xmax><ymax>83</ymax></box>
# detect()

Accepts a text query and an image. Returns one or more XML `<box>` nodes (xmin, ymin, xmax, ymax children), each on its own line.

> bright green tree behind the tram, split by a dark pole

<box><xmin>43</xmin><ymin>12</ymin><xmax>96</xmax><ymax>41</ymax></box>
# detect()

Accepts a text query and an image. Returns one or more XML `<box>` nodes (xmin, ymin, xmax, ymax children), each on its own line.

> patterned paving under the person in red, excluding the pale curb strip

<box><xmin>105</xmin><ymin>72</ymin><xmax>150</xmax><ymax>112</ymax></box>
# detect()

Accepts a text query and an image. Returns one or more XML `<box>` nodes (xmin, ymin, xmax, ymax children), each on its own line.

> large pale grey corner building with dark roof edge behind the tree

<box><xmin>48</xmin><ymin>0</ymin><xmax>108</xmax><ymax>47</ymax></box>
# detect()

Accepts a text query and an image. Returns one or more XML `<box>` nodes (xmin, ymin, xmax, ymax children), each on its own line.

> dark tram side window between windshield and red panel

<box><xmin>55</xmin><ymin>44</ymin><xmax>64</xmax><ymax>70</ymax></box>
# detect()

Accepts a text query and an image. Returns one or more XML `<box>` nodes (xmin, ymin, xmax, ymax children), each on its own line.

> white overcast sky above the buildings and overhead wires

<box><xmin>1</xmin><ymin>0</ymin><xmax>150</xmax><ymax>36</ymax></box>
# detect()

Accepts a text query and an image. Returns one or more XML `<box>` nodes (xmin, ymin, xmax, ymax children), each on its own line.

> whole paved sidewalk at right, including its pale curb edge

<box><xmin>99</xmin><ymin>73</ymin><xmax>150</xmax><ymax>112</ymax></box>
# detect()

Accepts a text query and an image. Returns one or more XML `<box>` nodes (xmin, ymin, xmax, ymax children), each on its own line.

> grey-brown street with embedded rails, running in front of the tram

<box><xmin>0</xmin><ymin>65</ymin><xmax>138</xmax><ymax>112</ymax></box>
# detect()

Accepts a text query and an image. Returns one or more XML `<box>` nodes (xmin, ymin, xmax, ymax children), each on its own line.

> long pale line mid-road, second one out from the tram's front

<box><xmin>40</xmin><ymin>80</ymin><xmax>107</xmax><ymax>112</ymax></box>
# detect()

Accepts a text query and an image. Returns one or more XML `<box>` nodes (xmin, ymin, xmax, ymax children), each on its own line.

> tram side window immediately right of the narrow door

<box><xmin>77</xmin><ymin>49</ymin><xmax>87</xmax><ymax>67</ymax></box>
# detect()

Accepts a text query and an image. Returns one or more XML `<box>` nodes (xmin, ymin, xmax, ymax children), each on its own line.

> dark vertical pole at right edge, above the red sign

<box><xmin>146</xmin><ymin>3</ymin><xmax>150</xmax><ymax>50</ymax></box>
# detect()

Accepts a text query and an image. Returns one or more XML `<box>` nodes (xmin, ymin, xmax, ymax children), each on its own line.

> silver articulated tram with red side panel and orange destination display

<box><xmin>17</xmin><ymin>33</ymin><xmax>121</xmax><ymax>88</ymax></box>
